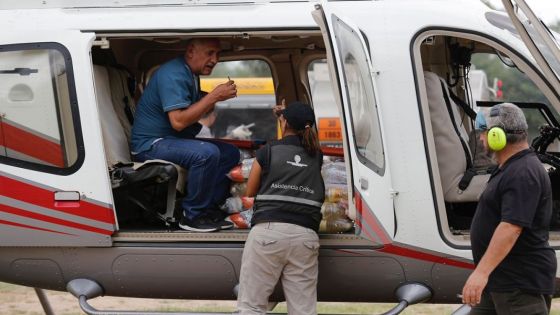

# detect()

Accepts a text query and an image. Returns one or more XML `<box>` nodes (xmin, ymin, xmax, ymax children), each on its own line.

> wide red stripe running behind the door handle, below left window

<box><xmin>0</xmin><ymin>176</ymin><xmax>115</xmax><ymax>224</ymax></box>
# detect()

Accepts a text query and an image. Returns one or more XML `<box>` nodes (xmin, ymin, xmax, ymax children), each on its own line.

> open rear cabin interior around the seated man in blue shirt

<box><xmin>86</xmin><ymin>30</ymin><xmax>355</xmax><ymax>239</ymax></box>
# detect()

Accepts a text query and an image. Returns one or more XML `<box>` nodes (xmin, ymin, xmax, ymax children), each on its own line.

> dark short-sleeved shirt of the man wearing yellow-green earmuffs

<box><xmin>471</xmin><ymin>149</ymin><xmax>556</xmax><ymax>294</ymax></box>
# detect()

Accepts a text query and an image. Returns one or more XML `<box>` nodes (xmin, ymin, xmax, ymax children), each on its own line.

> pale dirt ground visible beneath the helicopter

<box><xmin>0</xmin><ymin>283</ymin><xmax>560</xmax><ymax>315</ymax></box>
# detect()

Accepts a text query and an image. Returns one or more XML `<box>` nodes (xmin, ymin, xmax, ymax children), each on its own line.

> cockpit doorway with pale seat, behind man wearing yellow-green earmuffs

<box><xmin>413</xmin><ymin>30</ymin><xmax>560</xmax><ymax>245</ymax></box>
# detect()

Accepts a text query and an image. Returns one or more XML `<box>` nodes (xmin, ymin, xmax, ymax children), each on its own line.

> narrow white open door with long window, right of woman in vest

<box><xmin>312</xmin><ymin>2</ymin><xmax>395</xmax><ymax>245</ymax></box>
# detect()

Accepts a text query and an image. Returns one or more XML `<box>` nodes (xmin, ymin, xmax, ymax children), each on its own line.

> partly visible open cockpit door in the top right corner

<box><xmin>502</xmin><ymin>0</ymin><xmax>560</xmax><ymax>110</ymax></box>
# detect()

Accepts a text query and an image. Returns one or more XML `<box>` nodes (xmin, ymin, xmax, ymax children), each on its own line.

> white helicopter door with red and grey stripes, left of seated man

<box><xmin>0</xmin><ymin>29</ymin><xmax>116</xmax><ymax>247</ymax></box>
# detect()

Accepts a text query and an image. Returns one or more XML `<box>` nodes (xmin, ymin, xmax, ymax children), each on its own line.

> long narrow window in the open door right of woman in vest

<box><xmin>334</xmin><ymin>20</ymin><xmax>385</xmax><ymax>173</ymax></box>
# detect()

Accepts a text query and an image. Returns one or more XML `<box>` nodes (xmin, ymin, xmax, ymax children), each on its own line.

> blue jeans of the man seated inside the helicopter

<box><xmin>133</xmin><ymin>137</ymin><xmax>243</xmax><ymax>220</ymax></box>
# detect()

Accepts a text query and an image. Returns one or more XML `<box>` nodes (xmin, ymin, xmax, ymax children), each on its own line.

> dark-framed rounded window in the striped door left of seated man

<box><xmin>0</xmin><ymin>43</ymin><xmax>83</xmax><ymax>173</ymax></box>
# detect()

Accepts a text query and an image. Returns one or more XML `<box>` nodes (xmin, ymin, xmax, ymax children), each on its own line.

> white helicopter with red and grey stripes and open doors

<box><xmin>0</xmin><ymin>0</ymin><xmax>560</xmax><ymax>314</ymax></box>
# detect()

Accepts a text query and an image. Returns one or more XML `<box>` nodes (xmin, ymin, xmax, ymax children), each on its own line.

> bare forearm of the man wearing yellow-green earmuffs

<box><xmin>476</xmin><ymin>222</ymin><xmax>522</xmax><ymax>275</ymax></box>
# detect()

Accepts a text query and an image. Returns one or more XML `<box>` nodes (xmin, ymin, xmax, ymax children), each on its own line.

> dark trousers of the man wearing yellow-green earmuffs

<box><xmin>470</xmin><ymin>290</ymin><xmax>551</xmax><ymax>315</ymax></box>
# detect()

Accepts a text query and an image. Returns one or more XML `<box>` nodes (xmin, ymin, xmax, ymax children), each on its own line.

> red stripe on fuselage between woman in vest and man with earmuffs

<box><xmin>354</xmin><ymin>193</ymin><xmax>474</xmax><ymax>269</ymax></box>
